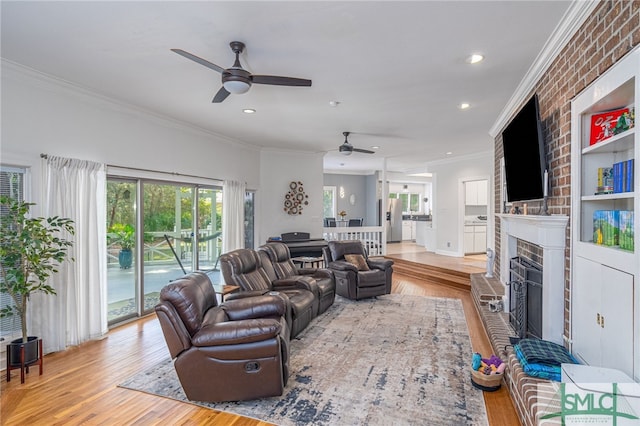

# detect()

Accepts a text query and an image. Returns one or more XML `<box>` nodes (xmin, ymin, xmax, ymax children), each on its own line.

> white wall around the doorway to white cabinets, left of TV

<box><xmin>429</xmin><ymin>152</ymin><xmax>493</xmax><ymax>257</ymax></box>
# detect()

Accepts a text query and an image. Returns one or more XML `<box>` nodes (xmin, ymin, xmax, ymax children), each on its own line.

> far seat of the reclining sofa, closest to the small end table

<box><xmin>258</xmin><ymin>242</ymin><xmax>336</xmax><ymax>315</ymax></box>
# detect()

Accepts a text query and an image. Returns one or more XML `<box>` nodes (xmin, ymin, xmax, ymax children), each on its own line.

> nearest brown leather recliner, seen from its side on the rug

<box><xmin>155</xmin><ymin>272</ymin><xmax>289</xmax><ymax>402</ymax></box>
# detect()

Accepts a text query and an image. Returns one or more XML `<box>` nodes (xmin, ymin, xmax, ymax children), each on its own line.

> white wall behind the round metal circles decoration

<box><xmin>256</xmin><ymin>150</ymin><xmax>323</xmax><ymax>245</ymax></box>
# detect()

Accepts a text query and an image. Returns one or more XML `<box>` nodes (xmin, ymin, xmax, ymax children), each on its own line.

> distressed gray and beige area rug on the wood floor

<box><xmin>120</xmin><ymin>294</ymin><xmax>488</xmax><ymax>425</ymax></box>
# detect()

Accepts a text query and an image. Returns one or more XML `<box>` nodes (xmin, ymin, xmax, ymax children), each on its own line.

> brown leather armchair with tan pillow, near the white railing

<box><xmin>323</xmin><ymin>240</ymin><xmax>393</xmax><ymax>300</ymax></box>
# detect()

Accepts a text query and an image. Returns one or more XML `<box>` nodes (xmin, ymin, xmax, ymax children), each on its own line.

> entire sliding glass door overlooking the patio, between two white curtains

<box><xmin>106</xmin><ymin>178</ymin><xmax>229</xmax><ymax>324</ymax></box>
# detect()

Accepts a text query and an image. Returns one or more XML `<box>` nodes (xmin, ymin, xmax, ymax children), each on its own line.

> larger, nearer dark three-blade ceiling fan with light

<box><xmin>171</xmin><ymin>41</ymin><xmax>311</xmax><ymax>103</ymax></box>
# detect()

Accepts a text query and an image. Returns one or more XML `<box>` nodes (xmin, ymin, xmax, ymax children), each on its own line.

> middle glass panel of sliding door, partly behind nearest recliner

<box><xmin>141</xmin><ymin>182</ymin><xmax>197</xmax><ymax>312</ymax></box>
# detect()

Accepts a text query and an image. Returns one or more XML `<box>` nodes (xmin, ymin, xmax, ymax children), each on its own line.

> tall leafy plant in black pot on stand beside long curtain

<box><xmin>0</xmin><ymin>195</ymin><xmax>74</xmax><ymax>366</ymax></box>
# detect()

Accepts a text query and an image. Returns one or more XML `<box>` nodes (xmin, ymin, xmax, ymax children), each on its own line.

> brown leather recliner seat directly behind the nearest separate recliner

<box><xmin>220</xmin><ymin>249</ymin><xmax>319</xmax><ymax>338</ymax></box>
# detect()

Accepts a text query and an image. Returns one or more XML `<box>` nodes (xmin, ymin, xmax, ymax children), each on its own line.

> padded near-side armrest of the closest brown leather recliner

<box><xmin>191</xmin><ymin>318</ymin><xmax>282</xmax><ymax>347</ymax></box>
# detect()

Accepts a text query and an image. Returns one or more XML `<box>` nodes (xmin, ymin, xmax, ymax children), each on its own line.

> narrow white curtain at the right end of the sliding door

<box><xmin>222</xmin><ymin>180</ymin><xmax>246</xmax><ymax>253</ymax></box>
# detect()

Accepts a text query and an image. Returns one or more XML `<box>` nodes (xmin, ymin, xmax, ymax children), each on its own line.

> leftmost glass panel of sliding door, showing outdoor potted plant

<box><xmin>106</xmin><ymin>179</ymin><xmax>138</xmax><ymax>324</ymax></box>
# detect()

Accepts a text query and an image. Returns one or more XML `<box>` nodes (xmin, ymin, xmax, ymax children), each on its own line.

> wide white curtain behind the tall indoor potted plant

<box><xmin>30</xmin><ymin>156</ymin><xmax>108</xmax><ymax>352</ymax></box>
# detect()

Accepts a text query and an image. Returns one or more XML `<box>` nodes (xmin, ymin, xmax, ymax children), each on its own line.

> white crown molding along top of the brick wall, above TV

<box><xmin>489</xmin><ymin>0</ymin><xmax>600</xmax><ymax>139</ymax></box>
